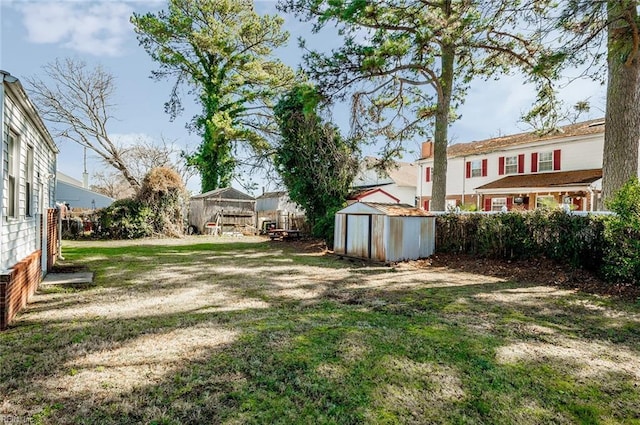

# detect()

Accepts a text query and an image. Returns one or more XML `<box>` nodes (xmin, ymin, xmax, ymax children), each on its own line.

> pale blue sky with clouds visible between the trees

<box><xmin>0</xmin><ymin>0</ymin><xmax>605</xmax><ymax>195</ymax></box>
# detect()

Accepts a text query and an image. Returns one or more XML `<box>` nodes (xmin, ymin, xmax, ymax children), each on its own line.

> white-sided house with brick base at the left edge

<box><xmin>0</xmin><ymin>71</ymin><xmax>58</xmax><ymax>327</ymax></box>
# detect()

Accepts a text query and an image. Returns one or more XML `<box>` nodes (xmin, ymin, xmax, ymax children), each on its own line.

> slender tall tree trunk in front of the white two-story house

<box><xmin>430</xmin><ymin>46</ymin><xmax>455</xmax><ymax>211</ymax></box>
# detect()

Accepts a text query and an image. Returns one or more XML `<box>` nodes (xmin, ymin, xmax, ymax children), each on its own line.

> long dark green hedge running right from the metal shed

<box><xmin>436</xmin><ymin>210</ymin><xmax>640</xmax><ymax>285</ymax></box>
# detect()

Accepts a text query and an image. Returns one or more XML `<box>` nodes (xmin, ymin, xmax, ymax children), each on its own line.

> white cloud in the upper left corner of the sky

<box><xmin>16</xmin><ymin>1</ymin><xmax>133</xmax><ymax>56</ymax></box>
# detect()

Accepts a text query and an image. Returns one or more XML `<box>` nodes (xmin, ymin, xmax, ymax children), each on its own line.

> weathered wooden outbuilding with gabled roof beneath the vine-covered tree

<box><xmin>189</xmin><ymin>187</ymin><xmax>256</xmax><ymax>234</ymax></box>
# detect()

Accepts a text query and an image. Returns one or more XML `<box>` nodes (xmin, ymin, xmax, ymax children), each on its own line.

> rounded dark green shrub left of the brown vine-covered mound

<box><xmin>98</xmin><ymin>199</ymin><xmax>153</xmax><ymax>239</ymax></box>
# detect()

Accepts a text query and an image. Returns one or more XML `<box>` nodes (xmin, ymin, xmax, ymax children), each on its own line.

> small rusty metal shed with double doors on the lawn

<box><xmin>333</xmin><ymin>202</ymin><xmax>436</xmax><ymax>262</ymax></box>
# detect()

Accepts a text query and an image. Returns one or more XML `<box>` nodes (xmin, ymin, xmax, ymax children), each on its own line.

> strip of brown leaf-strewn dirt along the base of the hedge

<box><xmin>412</xmin><ymin>254</ymin><xmax>640</xmax><ymax>301</ymax></box>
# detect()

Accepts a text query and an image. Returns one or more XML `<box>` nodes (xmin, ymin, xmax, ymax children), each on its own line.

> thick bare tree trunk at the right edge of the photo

<box><xmin>602</xmin><ymin>0</ymin><xmax>640</xmax><ymax>202</ymax></box>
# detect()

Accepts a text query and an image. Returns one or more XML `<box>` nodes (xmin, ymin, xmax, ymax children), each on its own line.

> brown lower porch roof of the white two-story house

<box><xmin>476</xmin><ymin>168</ymin><xmax>602</xmax><ymax>190</ymax></box>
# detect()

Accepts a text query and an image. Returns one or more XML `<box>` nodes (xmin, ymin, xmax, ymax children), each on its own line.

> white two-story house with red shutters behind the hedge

<box><xmin>417</xmin><ymin>119</ymin><xmax>616</xmax><ymax>211</ymax></box>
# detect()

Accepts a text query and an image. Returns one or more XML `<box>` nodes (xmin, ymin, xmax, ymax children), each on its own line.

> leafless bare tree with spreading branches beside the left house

<box><xmin>26</xmin><ymin>58</ymin><xmax>140</xmax><ymax>190</ymax></box>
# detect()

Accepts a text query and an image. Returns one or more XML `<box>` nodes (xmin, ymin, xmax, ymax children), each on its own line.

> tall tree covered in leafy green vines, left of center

<box><xmin>131</xmin><ymin>0</ymin><xmax>295</xmax><ymax>192</ymax></box>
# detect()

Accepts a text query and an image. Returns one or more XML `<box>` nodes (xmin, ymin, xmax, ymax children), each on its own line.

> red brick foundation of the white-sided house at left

<box><xmin>0</xmin><ymin>250</ymin><xmax>42</xmax><ymax>330</ymax></box>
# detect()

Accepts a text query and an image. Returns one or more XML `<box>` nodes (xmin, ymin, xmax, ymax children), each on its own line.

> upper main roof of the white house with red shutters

<box><xmin>421</xmin><ymin>118</ymin><xmax>604</xmax><ymax>159</ymax></box>
